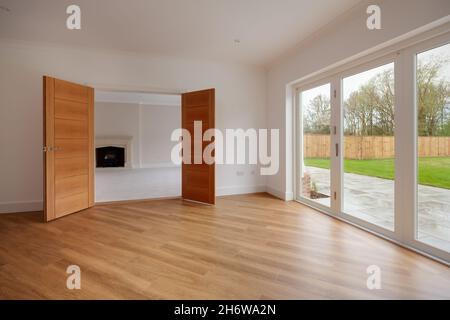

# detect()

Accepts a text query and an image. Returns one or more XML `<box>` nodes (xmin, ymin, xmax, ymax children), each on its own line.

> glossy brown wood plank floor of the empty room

<box><xmin>0</xmin><ymin>194</ymin><xmax>450</xmax><ymax>299</ymax></box>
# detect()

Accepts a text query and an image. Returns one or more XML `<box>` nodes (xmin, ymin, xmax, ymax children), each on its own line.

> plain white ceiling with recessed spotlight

<box><xmin>0</xmin><ymin>0</ymin><xmax>360</xmax><ymax>65</ymax></box>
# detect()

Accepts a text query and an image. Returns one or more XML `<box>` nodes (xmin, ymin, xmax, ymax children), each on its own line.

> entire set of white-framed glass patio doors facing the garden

<box><xmin>294</xmin><ymin>31</ymin><xmax>450</xmax><ymax>263</ymax></box>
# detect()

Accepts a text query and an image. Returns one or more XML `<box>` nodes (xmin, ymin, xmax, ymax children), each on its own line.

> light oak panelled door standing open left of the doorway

<box><xmin>44</xmin><ymin>76</ymin><xmax>94</xmax><ymax>221</ymax></box>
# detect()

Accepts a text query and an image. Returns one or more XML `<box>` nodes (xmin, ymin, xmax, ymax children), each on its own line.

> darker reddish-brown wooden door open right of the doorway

<box><xmin>181</xmin><ymin>89</ymin><xmax>215</xmax><ymax>204</ymax></box>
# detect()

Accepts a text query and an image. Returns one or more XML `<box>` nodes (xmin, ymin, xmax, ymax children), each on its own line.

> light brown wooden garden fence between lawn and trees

<box><xmin>304</xmin><ymin>134</ymin><xmax>450</xmax><ymax>160</ymax></box>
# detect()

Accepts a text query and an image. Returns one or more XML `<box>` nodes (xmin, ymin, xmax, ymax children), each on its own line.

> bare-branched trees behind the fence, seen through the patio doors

<box><xmin>303</xmin><ymin>57</ymin><xmax>450</xmax><ymax>136</ymax></box>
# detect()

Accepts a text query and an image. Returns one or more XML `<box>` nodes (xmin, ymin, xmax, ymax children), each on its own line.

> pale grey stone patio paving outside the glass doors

<box><xmin>306</xmin><ymin>167</ymin><xmax>450</xmax><ymax>252</ymax></box>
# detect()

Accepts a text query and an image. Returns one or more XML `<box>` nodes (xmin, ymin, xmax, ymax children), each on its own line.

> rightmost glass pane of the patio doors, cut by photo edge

<box><xmin>416</xmin><ymin>44</ymin><xmax>450</xmax><ymax>251</ymax></box>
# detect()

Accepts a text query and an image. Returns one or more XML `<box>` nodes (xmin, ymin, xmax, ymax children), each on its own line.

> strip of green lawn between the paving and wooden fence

<box><xmin>305</xmin><ymin>157</ymin><xmax>450</xmax><ymax>189</ymax></box>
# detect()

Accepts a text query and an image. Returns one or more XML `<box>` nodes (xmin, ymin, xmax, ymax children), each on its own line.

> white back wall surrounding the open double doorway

<box><xmin>0</xmin><ymin>40</ymin><xmax>266</xmax><ymax>212</ymax></box>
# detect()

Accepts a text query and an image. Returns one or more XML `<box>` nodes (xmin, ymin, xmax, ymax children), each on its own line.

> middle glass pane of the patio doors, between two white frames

<box><xmin>343</xmin><ymin>63</ymin><xmax>395</xmax><ymax>230</ymax></box>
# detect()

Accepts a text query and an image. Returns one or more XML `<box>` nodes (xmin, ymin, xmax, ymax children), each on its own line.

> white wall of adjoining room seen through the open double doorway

<box><xmin>94</xmin><ymin>100</ymin><xmax>181</xmax><ymax>202</ymax></box>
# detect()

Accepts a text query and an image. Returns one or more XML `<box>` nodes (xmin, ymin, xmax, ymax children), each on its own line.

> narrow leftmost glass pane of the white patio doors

<box><xmin>300</xmin><ymin>83</ymin><xmax>331</xmax><ymax>207</ymax></box>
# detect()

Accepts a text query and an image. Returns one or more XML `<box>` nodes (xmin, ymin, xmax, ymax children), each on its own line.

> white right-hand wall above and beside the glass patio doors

<box><xmin>267</xmin><ymin>0</ymin><xmax>450</xmax><ymax>199</ymax></box>
